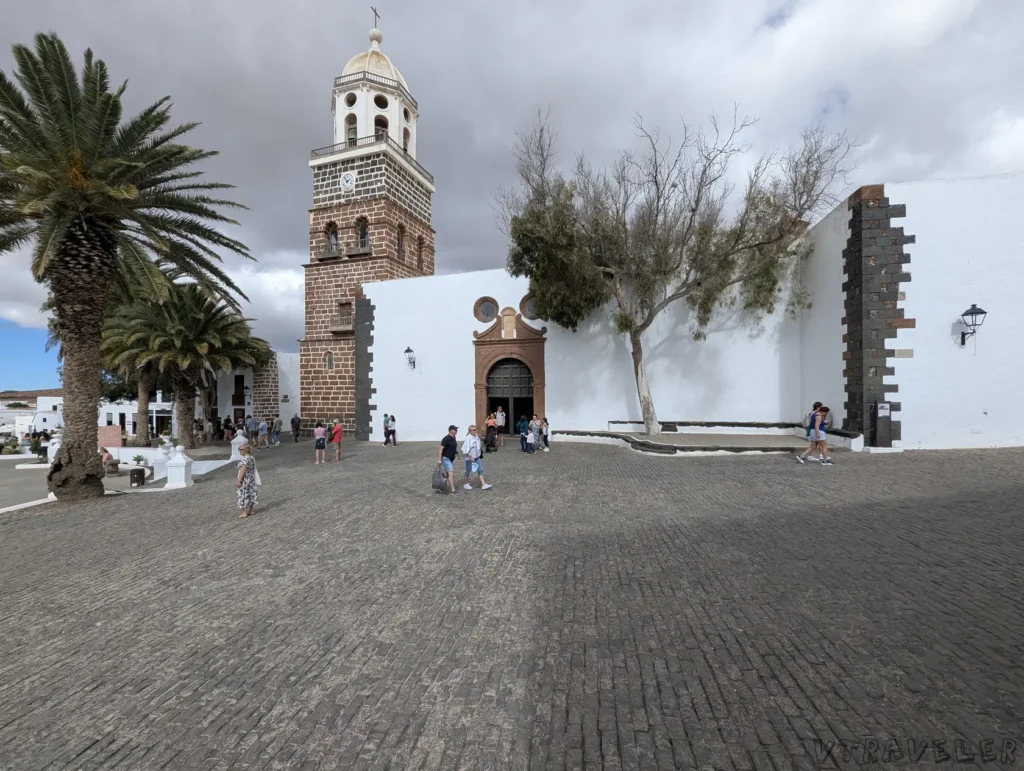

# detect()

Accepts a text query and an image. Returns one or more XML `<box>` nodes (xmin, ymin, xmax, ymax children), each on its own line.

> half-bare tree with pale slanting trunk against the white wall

<box><xmin>498</xmin><ymin>110</ymin><xmax>852</xmax><ymax>434</ymax></box>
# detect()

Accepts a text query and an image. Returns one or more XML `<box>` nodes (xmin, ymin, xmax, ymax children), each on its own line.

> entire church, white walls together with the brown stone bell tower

<box><xmin>298</xmin><ymin>30</ymin><xmax>1024</xmax><ymax>448</ymax></box>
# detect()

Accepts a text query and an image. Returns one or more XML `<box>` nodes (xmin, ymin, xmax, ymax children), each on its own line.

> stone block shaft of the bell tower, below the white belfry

<box><xmin>299</xmin><ymin>151</ymin><xmax>434</xmax><ymax>438</ymax></box>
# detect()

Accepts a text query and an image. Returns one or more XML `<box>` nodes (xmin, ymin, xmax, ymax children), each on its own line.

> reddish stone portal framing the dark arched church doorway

<box><xmin>473</xmin><ymin>298</ymin><xmax>548</xmax><ymax>431</ymax></box>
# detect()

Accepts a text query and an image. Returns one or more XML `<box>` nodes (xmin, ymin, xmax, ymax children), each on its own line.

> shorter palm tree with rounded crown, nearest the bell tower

<box><xmin>102</xmin><ymin>284</ymin><xmax>270</xmax><ymax>447</ymax></box>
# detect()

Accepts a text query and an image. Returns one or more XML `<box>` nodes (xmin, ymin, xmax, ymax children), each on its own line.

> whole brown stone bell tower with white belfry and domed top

<box><xmin>299</xmin><ymin>28</ymin><xmax>434</xmax><ymax>438</ymax></box>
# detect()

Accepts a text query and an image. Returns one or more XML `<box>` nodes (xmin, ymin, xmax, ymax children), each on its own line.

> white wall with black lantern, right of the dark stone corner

<box><xmin>886</xmin><ymin>174</ymin><xmax>1024</xmax><ymax>448</ymax></box>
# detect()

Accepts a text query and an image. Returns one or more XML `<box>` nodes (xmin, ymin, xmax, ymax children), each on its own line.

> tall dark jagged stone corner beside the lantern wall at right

<box><xmin>843</xmin><ymin>184</ymin><xmax>915</xmax><ymax>446</ymax></box>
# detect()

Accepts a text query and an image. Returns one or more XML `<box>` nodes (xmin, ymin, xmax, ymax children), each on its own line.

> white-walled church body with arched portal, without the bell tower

<box><xmin>354</xmin><ymin>174</ymin><xmax>1024</xmax><ymax>448</ymax></box>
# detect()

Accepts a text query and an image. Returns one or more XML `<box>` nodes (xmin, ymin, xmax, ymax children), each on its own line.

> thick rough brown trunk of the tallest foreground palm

<box><xmin>46</xmin><ymin>226</ymin><xmax>114</xmax><ymax>501</ymax></box>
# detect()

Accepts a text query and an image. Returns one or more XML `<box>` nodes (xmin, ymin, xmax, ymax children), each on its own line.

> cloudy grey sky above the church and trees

<box><xmin>0</xmin><ymin>0</ymin><xmax>1024</xmax><ymax>388</ymax></box>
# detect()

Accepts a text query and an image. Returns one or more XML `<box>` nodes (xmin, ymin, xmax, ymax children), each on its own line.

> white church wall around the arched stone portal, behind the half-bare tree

<box><xmin>364</xmin><ymin>270</ymin><xmax>802</xmax><ymax>441</ymax></box>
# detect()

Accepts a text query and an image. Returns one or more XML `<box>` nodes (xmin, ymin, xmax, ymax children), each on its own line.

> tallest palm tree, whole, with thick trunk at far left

<box><xmin>0</xmin><ymin>33</ymin><xmax>249</xmax><ymax>500</ymax></box>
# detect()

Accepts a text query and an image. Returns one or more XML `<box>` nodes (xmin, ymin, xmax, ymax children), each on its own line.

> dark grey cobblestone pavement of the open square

<box><xmin>0</xmin><ymin>443</ymin><xmax>1024</xmax><ymax>771</ymax></box>
